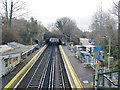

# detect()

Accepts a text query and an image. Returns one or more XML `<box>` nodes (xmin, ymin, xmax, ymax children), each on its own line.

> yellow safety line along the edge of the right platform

<box><xmin>60</xmin><ymin>45</ymin><xmax>83</xmax><ymax>89</ymax></box>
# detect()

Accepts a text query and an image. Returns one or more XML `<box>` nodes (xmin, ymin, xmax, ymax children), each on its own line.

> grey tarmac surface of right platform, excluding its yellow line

<box><xmin>62</xmin><ymin>46</ymin><xmax>95</xmax><ymax>89</ymax></box>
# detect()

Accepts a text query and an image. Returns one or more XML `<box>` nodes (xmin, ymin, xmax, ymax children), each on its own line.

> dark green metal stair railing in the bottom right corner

<box><xmin>93</xmin><ymin>70</ymin><xmax>120</xmax><ymax>89</ymax></box>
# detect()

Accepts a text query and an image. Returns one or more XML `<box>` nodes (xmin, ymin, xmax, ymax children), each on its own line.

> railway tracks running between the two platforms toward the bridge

<box><xmin>17</xmin><ymin>43</ymin><xmax>70</xmax><ymax>89</ymax></box>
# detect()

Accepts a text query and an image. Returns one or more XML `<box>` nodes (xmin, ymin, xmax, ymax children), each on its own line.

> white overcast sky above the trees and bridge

<box><xmin>25</xmin><ymin>0</ymin><xmax>118</xmax><ymax>30</ymax></box>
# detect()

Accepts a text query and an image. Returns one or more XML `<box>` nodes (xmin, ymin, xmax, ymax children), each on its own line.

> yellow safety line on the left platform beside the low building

<box><xmin>3</xmin><ymin>45</ymin><xmax>46</xmax><ymax>90</ymax></box>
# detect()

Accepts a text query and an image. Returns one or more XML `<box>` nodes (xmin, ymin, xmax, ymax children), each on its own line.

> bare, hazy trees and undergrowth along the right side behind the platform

<box><xmin>87</xmin><ymin>1</ymin><xmax>120</xmax><ymax>70</ymax></box>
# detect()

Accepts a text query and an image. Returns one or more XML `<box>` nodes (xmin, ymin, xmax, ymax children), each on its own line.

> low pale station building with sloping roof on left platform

<box><xmin>0</xmin><ymin>42</ymin><xmax>37</xmax><ymax>77</ymax></box>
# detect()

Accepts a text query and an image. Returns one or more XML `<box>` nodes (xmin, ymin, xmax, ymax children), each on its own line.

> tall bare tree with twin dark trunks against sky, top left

<box><xmin>0</xmin><ymin>0</ymin><xmax>28</xmax><ymax>27</ymax></box>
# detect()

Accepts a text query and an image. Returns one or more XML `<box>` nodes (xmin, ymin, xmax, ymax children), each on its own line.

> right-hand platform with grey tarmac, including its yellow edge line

<box><xmin>61</xmin><ymin>46</ymin><xmax>95</xmax><ymax>88</ymax></box>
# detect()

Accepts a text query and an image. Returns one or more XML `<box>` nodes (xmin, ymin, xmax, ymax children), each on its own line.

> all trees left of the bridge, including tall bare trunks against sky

<box><xmin>0</xmin><ymin>0</ymin><xmax>48</xmax><ymax>44</ymax></box>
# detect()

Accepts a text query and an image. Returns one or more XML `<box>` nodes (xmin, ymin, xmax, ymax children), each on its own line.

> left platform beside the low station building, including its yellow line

<box><xmin>2</xmin><ymin>46</ymin><xmax>45</xmax><ymax>88</ymax></box>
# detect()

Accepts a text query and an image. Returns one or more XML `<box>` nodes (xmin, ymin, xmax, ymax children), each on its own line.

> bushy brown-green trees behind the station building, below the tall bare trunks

<box><xmin>2</xmin><ymin>17</ymin><xmax>49</xmax><ymax>45</ymax></box>
